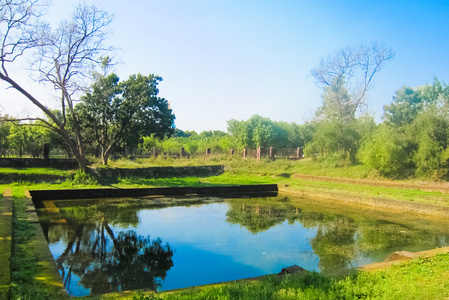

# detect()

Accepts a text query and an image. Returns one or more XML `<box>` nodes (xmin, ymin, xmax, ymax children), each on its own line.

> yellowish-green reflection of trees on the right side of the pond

<box><xmin>226</xmin><ymin>198</ymin><xmax>442</xmax><ymax>271</ymax></box>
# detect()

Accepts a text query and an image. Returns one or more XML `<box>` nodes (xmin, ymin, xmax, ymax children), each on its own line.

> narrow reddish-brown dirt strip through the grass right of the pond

<box><xmin>292</xmin><ymin>174</ymin><xmax>449</xmax><ymax>193</ymax></box>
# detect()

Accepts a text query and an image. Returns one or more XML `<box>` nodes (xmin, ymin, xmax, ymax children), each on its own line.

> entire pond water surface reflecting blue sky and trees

<box><xmin>39</xmin><ymin>196</ymin><xmax>449</xmax><ymax>296</ymax></box>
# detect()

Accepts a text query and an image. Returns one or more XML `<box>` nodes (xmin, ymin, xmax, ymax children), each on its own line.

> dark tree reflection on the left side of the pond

<box><xmin>50</xmin><ymin>207</ymin><xmax>173</xmax><ymax>294</ymax></box>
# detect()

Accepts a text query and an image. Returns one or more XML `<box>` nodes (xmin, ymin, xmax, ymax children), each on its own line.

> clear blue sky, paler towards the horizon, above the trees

<box><xmin>0</xmin><ymin>0</ymin><xmax>449</xmax><ymax>132</ymax></box>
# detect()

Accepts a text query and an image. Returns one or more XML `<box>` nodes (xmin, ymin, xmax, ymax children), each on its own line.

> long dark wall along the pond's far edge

<box><xmin>30</xmin><ymin>184</ymin><xmax>278</xmax><ymax>204</ymax></box>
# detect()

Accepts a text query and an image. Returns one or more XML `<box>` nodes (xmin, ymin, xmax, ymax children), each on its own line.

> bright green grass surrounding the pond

<box><xmin>0</xmin><ymin>157</ymin><xmax>449</xmax><ymax>299</ymax></box>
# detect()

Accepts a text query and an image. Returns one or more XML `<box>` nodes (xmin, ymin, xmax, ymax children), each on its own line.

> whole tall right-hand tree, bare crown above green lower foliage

<box><xmin>306</xmin><ymin>43</ymin><xmax>394</xmax><ymax>162</ymax></box>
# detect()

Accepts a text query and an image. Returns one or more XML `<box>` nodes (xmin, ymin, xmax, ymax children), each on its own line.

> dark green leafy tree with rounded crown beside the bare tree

<box><xmin>75</xmin><ymin>74</ymin><xmax>175</xmax><ymax>165</ymax></box>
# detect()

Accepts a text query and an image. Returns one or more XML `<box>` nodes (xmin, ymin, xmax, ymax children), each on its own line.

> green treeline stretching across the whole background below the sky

<box><xmin>0</xmin><ymin>78</ymin><xmax>449</xmax><ymax>178</ymax></box>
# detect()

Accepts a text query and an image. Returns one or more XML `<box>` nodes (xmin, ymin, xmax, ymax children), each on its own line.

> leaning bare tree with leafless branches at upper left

<box><xmin>0</xmin><ymin>0</ymin><xmax>112</xmax><ymax>171</ymax></box>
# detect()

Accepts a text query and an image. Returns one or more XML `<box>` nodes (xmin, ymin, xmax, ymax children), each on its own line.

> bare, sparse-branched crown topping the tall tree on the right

<box><xmin>311</xmin><ymin>42</ymin><xmax>394</xmax><ymax>124</ymax></box>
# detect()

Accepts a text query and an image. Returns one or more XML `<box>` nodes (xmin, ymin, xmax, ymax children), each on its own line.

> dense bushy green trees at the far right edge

<box><xmin>358</xmin><ymin>79</ymin><xmax>449</xmax><ymax>177</ymax></box>
